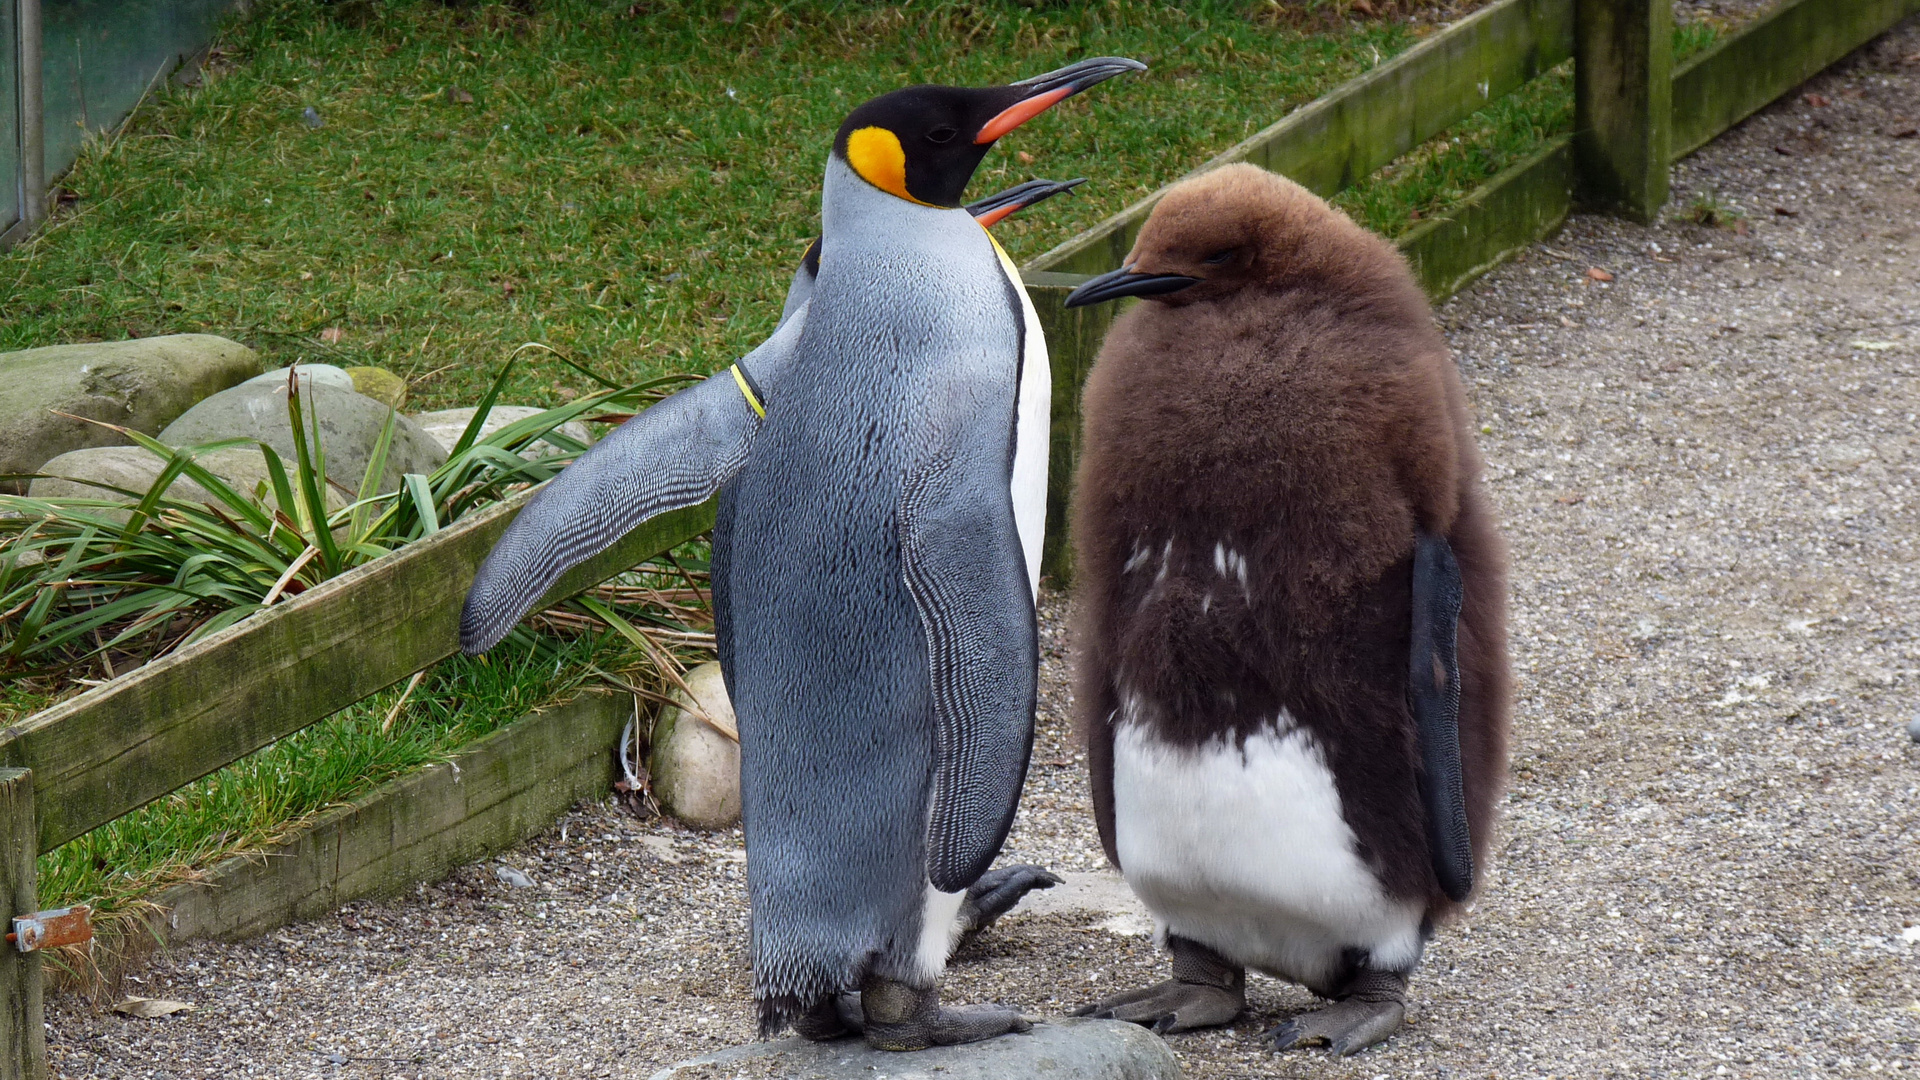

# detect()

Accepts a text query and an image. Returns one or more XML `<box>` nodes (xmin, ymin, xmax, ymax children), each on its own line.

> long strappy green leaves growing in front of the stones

<box><xmin>0</xmin><ymin>353</ymin><xmax>689</xmax><ymax>680</ymax></box>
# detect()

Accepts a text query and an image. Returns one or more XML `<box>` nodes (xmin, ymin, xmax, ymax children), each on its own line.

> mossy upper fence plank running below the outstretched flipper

<box><xmin>0</xmin><ymin>484</ymin><xmax>712</xmax><ymax>851</ymax></box>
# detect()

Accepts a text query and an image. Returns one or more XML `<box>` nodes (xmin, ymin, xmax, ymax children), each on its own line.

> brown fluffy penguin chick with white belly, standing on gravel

<box><xmin>1069</xmin><ymin>165</ymin><xmax>1511</xmax><ymax>1053</ymax></box>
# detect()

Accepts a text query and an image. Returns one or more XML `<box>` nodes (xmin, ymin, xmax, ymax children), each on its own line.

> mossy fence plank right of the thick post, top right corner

<box><xmin>1672</xmin><ymin>0</ymin><xmax>1920</xmax><ymax>158</ymax></box>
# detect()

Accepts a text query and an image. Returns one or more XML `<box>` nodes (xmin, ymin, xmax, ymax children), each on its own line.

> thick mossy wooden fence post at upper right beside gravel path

<box><xmin>1572</xmin><ymin>0</ymin><xmax>1674</xmax><ymax>221</ymax></box>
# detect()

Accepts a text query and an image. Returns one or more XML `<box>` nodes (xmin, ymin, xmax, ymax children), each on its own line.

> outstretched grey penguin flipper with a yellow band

<box><xmin>461</xmin><ymin>311</ymin><xmax>806</xmax><ymax>655</ymax></box>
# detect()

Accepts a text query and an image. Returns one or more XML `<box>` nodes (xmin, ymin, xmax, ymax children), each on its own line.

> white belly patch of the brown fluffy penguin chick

<box><xmin>1114</xmin><ymin>713</ymin><xmax>1425</xmax><ymax>990</ymax></box>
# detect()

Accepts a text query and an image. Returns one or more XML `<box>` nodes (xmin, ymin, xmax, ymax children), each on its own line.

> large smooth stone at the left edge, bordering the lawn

<box><xmin>0</xmin><ymin>334</ymin><xmax>259</xmax><ymax>494</ymax></box>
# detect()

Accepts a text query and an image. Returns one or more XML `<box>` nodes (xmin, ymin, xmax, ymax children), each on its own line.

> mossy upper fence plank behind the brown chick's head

<box><xmin>1027</xmin><ymin>0</ymin><xmax>1572</xmax><ymax>273</ymax></box>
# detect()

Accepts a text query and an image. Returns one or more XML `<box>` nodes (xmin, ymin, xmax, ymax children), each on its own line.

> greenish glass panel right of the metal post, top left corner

<box><xmin>40</xmin><ymin>0</ymin><xmax>232</xmax><ymax>177</ymax></box>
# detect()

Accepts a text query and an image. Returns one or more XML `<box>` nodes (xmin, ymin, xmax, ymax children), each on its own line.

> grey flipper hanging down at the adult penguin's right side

<box><xmin>900</xmin><ymin>459</ymin><xmax>1037</xmax><ymax>892</ymax></box>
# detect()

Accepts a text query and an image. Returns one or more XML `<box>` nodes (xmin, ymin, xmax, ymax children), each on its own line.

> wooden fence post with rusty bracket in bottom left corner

<box><xmin>0</xmin><ymin>769</ymin><xmax>46</xmax><ymax>1080</ymax></box>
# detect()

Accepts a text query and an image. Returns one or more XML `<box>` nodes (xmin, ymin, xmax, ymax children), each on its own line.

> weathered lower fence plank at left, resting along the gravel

<box><xmin>157</xmin><ymin>694</ymin><xmax>632</xmax><ymax>944</ymax></box>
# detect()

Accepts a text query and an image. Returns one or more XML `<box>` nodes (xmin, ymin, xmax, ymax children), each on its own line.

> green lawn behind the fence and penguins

<box><xmin>0</xmin><ymin>0</ymin><xmax>1417</xmax><ymax>407</ymax></box>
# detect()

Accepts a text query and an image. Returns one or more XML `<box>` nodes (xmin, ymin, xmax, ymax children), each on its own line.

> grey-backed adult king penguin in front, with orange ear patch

<box><xmin>461</xmin><ymin>58</ymin><xmax>1144</xmax><ymax>1049</ymax></box>
